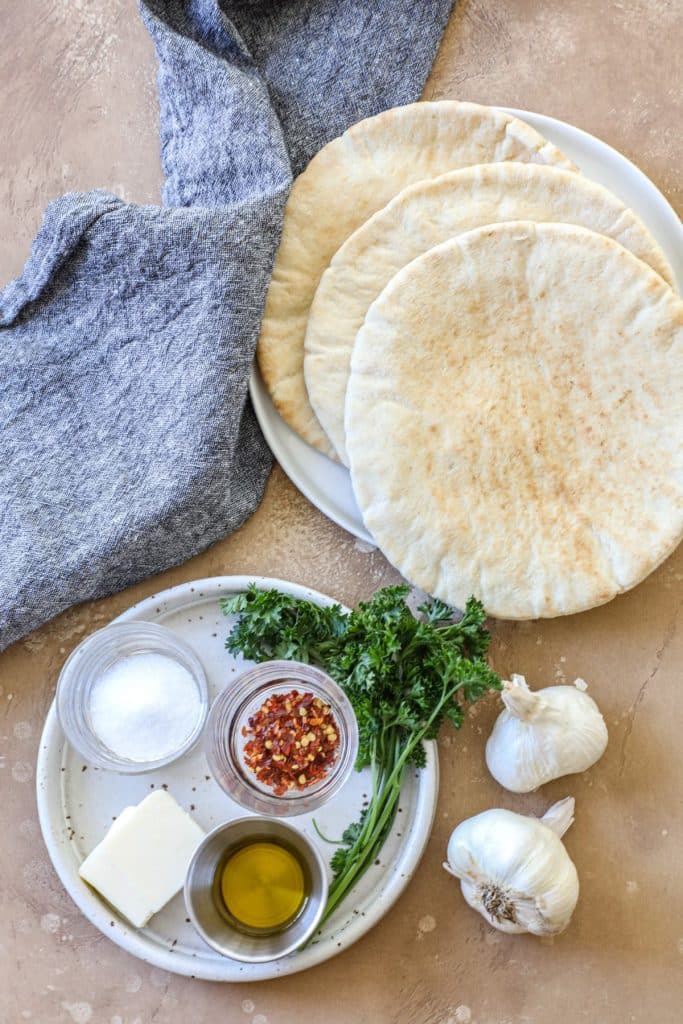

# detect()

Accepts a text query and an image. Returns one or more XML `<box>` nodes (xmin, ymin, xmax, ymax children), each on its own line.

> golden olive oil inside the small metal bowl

<box><xmin>215</xmin><ymin>839</ymin><xmax>308</xmax><ymax>935</ymax></box>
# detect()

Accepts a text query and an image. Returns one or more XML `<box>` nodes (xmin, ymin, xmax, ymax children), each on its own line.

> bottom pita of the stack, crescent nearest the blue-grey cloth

<box><xmin>257</xmin><ymin>100</ymin><xmax>572</xmax><ymax>458</ymax></box>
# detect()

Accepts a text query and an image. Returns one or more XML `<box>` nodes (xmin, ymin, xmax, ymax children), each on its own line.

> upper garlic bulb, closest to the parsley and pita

<box><xmin>486</xmin><ymin>676</ymin><xmax>607</xmax><ymax>793</ymax></box>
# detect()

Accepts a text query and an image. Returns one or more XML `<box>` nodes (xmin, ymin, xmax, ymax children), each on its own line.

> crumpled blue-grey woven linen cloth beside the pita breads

<box><xmin>0</xmin><ymin>0</ymin><xmax>453</xmax><ymax>648</ymax></box>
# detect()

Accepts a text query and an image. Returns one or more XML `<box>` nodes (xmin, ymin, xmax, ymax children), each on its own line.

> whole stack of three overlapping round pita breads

<box><xmin>258</xmin><ymin>101</ymin><xmax>683</xmax><ymax>618</ymax></box>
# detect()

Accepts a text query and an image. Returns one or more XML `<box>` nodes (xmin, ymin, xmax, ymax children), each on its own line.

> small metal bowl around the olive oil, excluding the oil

<box><xmin>184</xmin><ymin>817</ymin><xmax>328</xmax><ymax>964</ymax></box>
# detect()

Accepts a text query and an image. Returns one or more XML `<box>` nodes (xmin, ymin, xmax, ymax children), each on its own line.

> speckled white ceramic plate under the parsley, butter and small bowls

<box><xmin>36</xmin><ymin>577</ymin><xmax>438</xmax><ymax>981</ymax></box>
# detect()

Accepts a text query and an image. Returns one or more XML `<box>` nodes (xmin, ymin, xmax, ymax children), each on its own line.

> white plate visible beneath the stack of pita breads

<box><xmin>250</xmin><ymin>108</ymin><xmax>683</xmax><ymax>544</ymax></box>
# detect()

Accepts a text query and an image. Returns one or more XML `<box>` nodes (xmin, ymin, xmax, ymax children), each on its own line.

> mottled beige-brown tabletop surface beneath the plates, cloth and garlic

<box><xmin>0</xmin><ymin>0</ymin><xmax>683</xmax><ymax>1024</ymax></box>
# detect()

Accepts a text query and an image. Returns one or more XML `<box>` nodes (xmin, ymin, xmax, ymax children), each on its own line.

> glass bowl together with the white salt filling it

<box><xmin>56</xmin><ymin>623</ymin><xmax>209</xmax><ymax>774</ymax></box>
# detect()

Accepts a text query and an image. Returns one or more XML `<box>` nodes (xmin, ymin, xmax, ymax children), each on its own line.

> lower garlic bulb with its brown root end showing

<box><xmin>443</xmin><ymin>797</ymin><xmax>579</xmax><ymax>935</ymax></box>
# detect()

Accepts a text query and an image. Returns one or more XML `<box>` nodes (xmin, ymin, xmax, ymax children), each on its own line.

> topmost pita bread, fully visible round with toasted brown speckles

<box><xmin>345</xmin><ymin>221</ymin><xmax>683</xmax><ymax>618</ymax></box>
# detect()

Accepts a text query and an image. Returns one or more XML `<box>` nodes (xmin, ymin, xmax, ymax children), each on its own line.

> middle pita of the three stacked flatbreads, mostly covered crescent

<box><xmin>304</xmin><ymin>163</ymin><xmax>673</xmax><ymax>465</ymax></box>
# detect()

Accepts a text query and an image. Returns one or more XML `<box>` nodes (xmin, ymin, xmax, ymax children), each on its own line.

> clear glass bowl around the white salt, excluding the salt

<box><xmin>55</xmin><ymin>622</ymin><xmax>209</xmax><ymax>774</ymax></box>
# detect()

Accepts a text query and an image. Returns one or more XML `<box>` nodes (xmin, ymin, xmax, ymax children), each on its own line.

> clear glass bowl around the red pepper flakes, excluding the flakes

<box><xmin>205</xmin><ymin>660</ymin><xmax>358</xmax><ymax>817</ymax></box>
